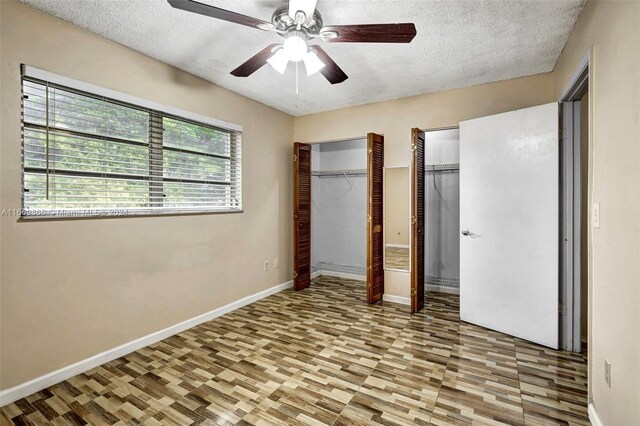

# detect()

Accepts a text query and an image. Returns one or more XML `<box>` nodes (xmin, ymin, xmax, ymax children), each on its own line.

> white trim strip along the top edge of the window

<box><xmin>22</xmin><ymin>64</ymin><xmax>242</xmax><ymax>132</ymax></box>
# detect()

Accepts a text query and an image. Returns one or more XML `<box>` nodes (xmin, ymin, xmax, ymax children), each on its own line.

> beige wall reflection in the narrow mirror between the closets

<box><xmin>384</xmin><ymin>167</ymin><xmax>410</xmax><ymax>245</ymax></box>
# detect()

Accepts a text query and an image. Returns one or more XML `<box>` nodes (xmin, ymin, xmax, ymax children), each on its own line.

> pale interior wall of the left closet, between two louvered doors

<box><xmin>311</xmin><ymin>139</ymin><xmax>367</xmax><ymax>280</ymax></box>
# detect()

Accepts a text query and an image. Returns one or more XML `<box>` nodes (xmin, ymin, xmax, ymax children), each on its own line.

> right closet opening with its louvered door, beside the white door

<box><xmin>410</xmin><ymin>127</ymin><xmax>460</xmax><ymax>312</ymax></box>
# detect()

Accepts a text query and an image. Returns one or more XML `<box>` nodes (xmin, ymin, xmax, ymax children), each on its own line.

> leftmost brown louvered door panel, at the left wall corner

<box><xmin>293</xmin><ymin>142</ymin><xmax>311</xmax><ymax>291</ymax></box>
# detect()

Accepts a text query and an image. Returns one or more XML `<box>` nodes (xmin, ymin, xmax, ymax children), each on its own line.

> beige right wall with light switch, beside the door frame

<box><xmin>554</xmin><ymin>1</ymin><xmax>640</xmax><ymax>425</ymax></box>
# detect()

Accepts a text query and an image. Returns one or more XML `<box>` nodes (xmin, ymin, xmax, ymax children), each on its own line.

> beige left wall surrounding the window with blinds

<box><xmin>0</xmin><ymin>0</ymin><xmax>293</xmax><ymax>389</ymax></box>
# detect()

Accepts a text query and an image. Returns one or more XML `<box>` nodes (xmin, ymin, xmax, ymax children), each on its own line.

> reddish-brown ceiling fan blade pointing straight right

<box><xmin>320</xmin><ymin>24</ymin><xmax>417</xmax><ymax>43</ymax></box>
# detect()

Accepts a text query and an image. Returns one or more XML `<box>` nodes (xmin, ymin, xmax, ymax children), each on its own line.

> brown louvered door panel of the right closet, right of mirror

<box><xmin>411</xmin><ymin>129</ymin><xmax>425</xmax><ymax>312</ymax></box>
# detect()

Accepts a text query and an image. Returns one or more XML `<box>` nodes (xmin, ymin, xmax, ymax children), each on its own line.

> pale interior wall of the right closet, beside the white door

<box><xmin>425</xmin><ymin>129</ymin><xmax>460</xmax><ymax>294</ymax></box>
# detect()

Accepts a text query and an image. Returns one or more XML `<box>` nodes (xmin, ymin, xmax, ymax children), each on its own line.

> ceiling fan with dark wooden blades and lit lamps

<box><xmin>167</xmin><ymin>0</ymin><xmax>416</xmax><ymax>84</ymax></box>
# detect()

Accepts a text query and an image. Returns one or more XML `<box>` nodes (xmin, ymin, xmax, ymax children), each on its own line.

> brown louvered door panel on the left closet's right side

<box><xmin>367</xmin><ymin>133</ymin><xmax>384</xmax><ymax>303</ymax></box>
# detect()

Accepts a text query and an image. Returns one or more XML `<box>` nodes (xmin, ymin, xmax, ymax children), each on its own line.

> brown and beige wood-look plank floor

<box><xmin>0</xmin><ymin>277</ymin><xmax>588</xmax><ymax>425</ymax></box>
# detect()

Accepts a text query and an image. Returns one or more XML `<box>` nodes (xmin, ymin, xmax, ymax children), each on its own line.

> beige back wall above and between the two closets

<box><xmin>294</xmin><ymin>73</ymin><xmax>554</xmax><ymax>298</ymax></box>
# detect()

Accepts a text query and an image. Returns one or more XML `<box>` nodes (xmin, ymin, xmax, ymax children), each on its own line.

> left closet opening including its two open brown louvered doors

<box><xmin>293</xmin><ymin>133</ymin><xmax>384</xmax><ymax>303</ymax></box>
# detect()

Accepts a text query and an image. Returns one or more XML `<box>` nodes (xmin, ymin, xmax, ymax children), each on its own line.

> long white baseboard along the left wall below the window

<box><xmin>0</xmin><ymin>281</ymin><xmax>293</xmax><ymax>407</ymax></box>
